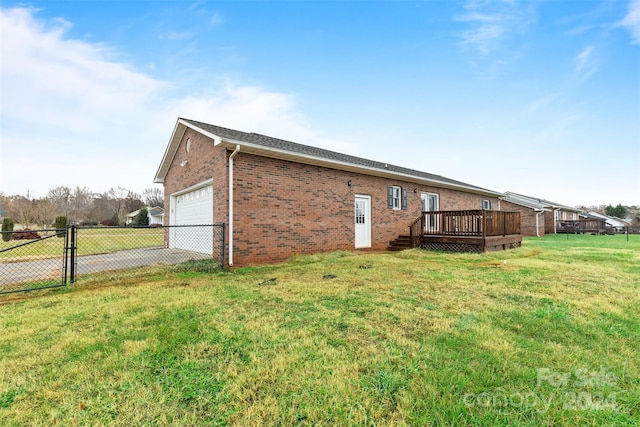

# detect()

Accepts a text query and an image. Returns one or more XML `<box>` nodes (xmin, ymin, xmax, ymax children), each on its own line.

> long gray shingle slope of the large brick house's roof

<box><xmin>181</xmin><ymin>118</ymin><xmax>497</xmax><ymax>193</ymax></box>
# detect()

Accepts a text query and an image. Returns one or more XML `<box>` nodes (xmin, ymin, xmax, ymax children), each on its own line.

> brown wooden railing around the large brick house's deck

<box><xmin>409</xmin><ymin>209</ymin><xmax>520</xmax><ymax>247</ymax></box>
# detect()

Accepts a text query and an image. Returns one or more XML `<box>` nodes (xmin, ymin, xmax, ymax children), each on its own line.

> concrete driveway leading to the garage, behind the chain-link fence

<box><xmin>0</xmin><ymin>247</ymin><xmax>212</xmax><ymax>292</ymax></box>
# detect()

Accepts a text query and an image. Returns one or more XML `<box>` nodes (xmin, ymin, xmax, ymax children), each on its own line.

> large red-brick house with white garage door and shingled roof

<box><xmin>154</xmin><ymin>119</ymin><xmax>503</xmax><ymax>265</ymax></box>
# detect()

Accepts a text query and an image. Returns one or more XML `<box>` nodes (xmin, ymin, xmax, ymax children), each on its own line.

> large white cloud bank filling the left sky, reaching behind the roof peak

<box><xmin>0</xmin><ymin>8</ymin><xmax>332</xmax><ymax>196</ymax></box>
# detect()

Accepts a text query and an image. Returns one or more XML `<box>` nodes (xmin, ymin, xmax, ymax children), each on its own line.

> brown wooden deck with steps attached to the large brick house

<box><xmin>389</xmin><ymin>210</ymin><xmax>522</xmax><ymax>252</ymax></box>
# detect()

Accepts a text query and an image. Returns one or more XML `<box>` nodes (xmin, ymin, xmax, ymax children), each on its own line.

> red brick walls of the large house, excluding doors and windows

<box><xmin>165</xmin><ymin>133</ymin><xmax>504</xmax><ymax>266</ymax></box>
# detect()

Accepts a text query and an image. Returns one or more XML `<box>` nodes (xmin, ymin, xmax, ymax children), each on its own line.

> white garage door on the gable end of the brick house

<box><xmin>169</xmin><ymin>185</ymin><xmax>213</xmax><ymax>254</ymax></box>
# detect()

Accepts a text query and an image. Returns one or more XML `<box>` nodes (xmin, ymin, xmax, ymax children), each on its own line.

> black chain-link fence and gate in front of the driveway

<box><xmin>0</xmin><ymin>223</ymin><xmax>225</xmax><ymax>295</ymax></box>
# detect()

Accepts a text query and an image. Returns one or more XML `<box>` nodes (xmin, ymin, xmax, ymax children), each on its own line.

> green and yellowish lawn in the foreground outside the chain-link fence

<box><xmin>0</xmin><ymin>235</ymin><xmax>640</xmax><ymax>426</ymax></box>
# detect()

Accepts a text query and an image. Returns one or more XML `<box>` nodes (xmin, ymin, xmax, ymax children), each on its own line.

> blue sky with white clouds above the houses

<box><xmin>0</xmin><ymin>0</ymin><xmax>640</xmax><ymax>206</ymax></box>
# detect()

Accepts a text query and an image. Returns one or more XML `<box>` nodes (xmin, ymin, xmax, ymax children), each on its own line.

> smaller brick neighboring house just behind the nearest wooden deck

<box><xmin>500</xmin><ymin>191</ymin><xmax>580</xmax><ymax>236</ymax></box>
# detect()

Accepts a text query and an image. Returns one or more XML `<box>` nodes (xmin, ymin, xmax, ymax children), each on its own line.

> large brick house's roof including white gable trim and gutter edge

<box><xmin>154</xmin><ymin>118</ymin><xmax>503</xmax><ymax>197</ymax></box>
